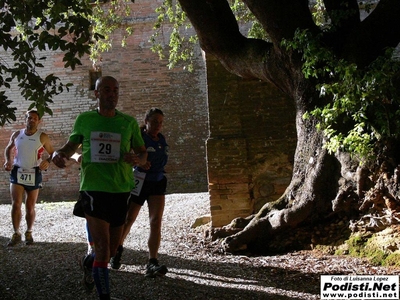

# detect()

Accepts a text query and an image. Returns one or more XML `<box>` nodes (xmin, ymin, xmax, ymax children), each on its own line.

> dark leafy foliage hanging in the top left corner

<box><xmin>0</xmin><ymin>0</ymin><xmax>97</xmax><ymax>126</ymax></box>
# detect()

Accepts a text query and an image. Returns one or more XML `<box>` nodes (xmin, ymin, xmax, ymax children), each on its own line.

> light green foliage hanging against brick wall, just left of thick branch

<box><xmin>150</xmin><ymin>0</ymin><xmax>198</xmax><ymax>72</ymax></box>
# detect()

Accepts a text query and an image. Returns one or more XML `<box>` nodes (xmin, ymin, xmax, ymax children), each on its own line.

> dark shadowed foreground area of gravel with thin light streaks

<box><xmin>0</xmin><ymin>237</ymin><xmax>319</xmax><ymax>300</ymax></box>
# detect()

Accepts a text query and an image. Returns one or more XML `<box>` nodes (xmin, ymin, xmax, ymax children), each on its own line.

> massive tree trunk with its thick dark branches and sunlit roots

<box><xmin>179</xmin><ymin>0</ymin><xmax>400</xmax><ymax>252</ymax></box>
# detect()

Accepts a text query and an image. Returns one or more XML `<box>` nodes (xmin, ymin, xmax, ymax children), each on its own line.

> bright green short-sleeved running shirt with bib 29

<box><xmin>69</xmin><ymin>110</ymin><xmax>144</xmax><ymax>193</ymax></box>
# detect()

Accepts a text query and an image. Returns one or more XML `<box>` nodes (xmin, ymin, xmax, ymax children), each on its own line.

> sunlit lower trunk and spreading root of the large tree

<box><xmin>224</xmin><ymin>106</ymin><xmax>350</xmax><ymax>252</ymax></box>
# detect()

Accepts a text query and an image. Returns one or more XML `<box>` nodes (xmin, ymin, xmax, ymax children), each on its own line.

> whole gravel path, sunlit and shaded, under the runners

<box><xmin>0</xmin><ymin>193</ymin><xmax>400</xmax><ymax>300</ymax></box>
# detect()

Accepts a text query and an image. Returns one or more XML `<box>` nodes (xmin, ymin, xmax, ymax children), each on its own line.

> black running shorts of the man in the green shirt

<box><xmin>73</xmin><ymin>191</ymin><xmax>131</xmax><ymax>227</ymax></box>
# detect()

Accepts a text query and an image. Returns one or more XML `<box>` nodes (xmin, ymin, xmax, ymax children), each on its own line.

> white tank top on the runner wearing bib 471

<box><xmin>14</xmin><ymin>129</ymin><xmax>45</xmax><ymax>169</ymax></box>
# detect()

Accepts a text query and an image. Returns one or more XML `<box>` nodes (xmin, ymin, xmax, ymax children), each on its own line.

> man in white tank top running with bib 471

<box><xmin>4</xmin><ymin>110</ymin><xmax>54</xmax><ymax>246</ymax></box>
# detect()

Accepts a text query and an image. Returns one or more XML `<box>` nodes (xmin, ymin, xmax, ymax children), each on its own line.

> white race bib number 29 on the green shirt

<box><xmin>90</xmin><ymin>131</ymin><xmax>121</xmax><ymax>163</ymax></box>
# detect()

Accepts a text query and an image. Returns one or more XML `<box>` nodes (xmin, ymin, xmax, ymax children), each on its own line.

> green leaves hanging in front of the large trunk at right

<box><xmin>283</xmin><ymin>31</ymin><xmax>400</xmax><ymax>162</ymax></box>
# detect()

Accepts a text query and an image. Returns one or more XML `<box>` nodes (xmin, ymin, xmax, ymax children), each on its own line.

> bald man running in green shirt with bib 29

<box><xmin>52</xmin><ymin>76</ymin><xmax>147</xmax><ymax>299</ymax></box>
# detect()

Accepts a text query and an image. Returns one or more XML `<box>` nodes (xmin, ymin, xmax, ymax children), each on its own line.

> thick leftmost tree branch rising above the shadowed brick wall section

<box><xmin>179</xmin><ymin>0</ymin><xmax>272</xmax><ymax>81</ymax></box>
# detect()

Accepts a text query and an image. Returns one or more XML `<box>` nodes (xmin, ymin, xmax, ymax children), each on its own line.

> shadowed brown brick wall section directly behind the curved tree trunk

<box><xmin>206</xmin><ymin>55</ymin><xmax>296</xmax><ymax>227</ymax></box>
